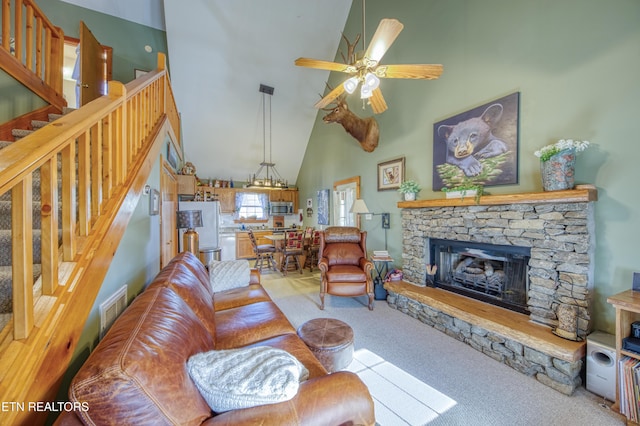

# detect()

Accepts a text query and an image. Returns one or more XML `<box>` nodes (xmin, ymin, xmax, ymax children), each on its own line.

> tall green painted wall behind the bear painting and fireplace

<box><xmin>297</xmin><ymin>0</ymin><xmax>640</xmax><ymax>333</ymax></box>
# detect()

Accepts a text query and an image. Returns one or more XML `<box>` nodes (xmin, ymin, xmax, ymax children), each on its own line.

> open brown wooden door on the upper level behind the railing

<box><xmin>78</xmin><ymin>21</ymin><xmax>107</xmax><ymax>106</ymax></box>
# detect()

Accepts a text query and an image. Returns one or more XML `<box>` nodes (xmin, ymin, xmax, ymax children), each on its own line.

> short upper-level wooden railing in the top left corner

<box><xmin>0</xmin><ymin>0</ymin><xmax>67</xmax><ymax>110</ymax></box>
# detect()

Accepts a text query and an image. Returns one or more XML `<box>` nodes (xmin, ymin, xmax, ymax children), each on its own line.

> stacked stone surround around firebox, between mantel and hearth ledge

<box><xmin>402</xmin><ymin>202</ymin><xmax>594</xmax><ymax>338</ymax></box>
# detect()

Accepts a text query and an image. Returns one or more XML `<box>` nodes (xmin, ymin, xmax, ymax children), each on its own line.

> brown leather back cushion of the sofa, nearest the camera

<box><xmin>69</xmin><ymin>286</ymin><xmax>213</xmax><ymax>425</ymax></box>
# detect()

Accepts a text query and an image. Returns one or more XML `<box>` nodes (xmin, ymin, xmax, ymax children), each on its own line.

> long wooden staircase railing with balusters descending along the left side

<box><xmin>0</xmin><ymin>54</ymin><xmax>181</xmax><ymax>424</ymax></box>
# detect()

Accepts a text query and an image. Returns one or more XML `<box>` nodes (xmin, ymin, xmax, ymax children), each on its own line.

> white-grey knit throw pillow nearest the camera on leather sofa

<box><xmin>187</xmin><ymin>346</ymin><xmax>309</xmax><ymax>413</ymax></box>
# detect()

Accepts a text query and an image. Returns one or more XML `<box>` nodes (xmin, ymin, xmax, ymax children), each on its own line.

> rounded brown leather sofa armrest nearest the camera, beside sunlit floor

<box><xmin>204</xmin><ymin>371</ymin><xmax>375</xmax><ymax>426</ymax></box>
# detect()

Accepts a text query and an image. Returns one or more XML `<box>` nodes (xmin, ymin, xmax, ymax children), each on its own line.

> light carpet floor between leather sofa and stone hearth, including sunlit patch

<box><xmin>262</xmin><ymin>270</ymin><xmax>625</xmax><ymax>426</ymax></box>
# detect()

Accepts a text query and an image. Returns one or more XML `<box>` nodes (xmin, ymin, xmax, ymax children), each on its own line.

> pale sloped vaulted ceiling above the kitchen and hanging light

<box><xmin>64</xmin><ymin>0</ymin><xmax>352</xmax><ymax>183</ymax></box>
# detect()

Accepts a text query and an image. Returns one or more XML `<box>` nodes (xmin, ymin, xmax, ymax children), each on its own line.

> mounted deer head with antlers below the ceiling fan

<box><xmin>322</xmin><ymin>96</ymin><xmax>380</xmax><ymax>152</ymax></box>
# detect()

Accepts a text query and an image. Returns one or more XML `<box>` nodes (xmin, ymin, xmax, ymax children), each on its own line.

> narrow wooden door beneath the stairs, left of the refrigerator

<box><xmin>160</xmin><ymin>161</ymin><xmax>178</xmax><ymax>268</ymax></box>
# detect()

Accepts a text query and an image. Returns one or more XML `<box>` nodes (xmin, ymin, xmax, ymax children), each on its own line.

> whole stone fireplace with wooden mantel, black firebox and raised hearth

<box><xmin>388</xmin><ymin>186</ymin><xmax>597</xmax><ymax>394</ymax></box>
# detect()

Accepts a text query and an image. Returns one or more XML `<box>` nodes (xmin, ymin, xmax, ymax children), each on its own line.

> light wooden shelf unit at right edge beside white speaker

<box><xmin>607</xmin><ymin>290</ymin><xmax>640</xmax><ymax>424</ymax></box>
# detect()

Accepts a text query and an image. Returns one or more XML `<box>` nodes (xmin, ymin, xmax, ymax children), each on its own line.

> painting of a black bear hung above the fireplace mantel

<box><xmin>433</xmin><ymin>92</ymin><xmax>520</xmax><ymax>191</ymax></box>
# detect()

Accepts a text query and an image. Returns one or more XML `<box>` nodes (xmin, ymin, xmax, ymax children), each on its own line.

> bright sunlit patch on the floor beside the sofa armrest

<box><xmin>345</xmin><ymin>349</ymin><xmax>456</xmax><ymax>426</ymax></box>
